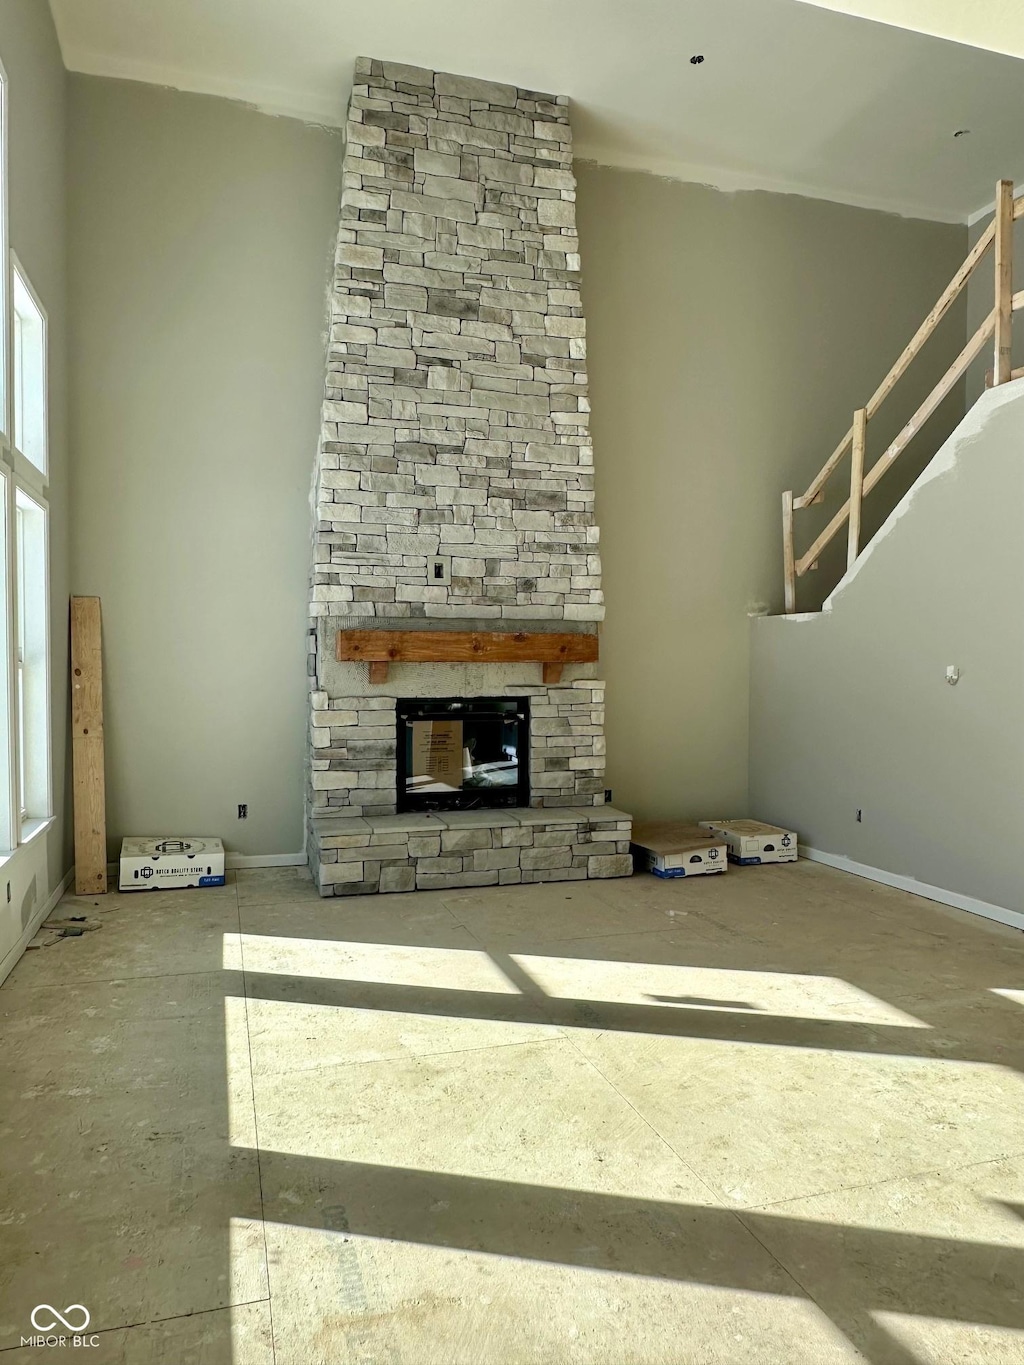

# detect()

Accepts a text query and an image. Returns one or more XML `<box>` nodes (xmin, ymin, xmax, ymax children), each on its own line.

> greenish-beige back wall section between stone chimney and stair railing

<box><xmin>578</xmin><ymin>159</ymin><xmax>967</xmax><ymax>816</ymax></box>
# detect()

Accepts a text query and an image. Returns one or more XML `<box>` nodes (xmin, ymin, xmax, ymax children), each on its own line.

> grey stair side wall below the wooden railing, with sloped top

<box><xmin>751</xmin><ymin>381</ymin><xmax>1024</xmax><ymax>913</ymax></box>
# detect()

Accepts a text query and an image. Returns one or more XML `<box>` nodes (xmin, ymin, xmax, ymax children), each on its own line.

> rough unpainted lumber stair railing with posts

<box><xmin>782</xmin><ymin>180</ymin><xmax>1024</xmax><ymax>613</ymax></box>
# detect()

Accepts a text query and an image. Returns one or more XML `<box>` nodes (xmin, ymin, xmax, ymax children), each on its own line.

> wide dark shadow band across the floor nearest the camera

<box><xmin>247</xmin><ymin>1151</ymin><xmax>1024</xmax><ymax>1365</ymax></box>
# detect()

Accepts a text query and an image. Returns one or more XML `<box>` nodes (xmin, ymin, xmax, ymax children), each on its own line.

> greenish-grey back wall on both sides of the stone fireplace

<box><xmin>70</xmin><ymin>76</ymin><xmax>965</xmax><ymax>853</ymax></box>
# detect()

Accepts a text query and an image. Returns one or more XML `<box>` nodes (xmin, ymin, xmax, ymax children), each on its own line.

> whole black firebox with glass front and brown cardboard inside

<box><xmin>396</xmin><ymin>696</ymin><xmax>530</xmax><ymax>811</ymax></box>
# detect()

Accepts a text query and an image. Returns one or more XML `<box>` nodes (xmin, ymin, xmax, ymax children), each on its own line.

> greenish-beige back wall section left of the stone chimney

<box><xmin>68</xmin><ymin>75</ymin><xmax>341</xmax><ymax>854</ymax></box>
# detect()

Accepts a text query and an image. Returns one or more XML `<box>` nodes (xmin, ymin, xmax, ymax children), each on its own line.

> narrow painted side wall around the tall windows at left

<box><xmin>0</xmin><ymin>0</ymin><xmax>71</xmax><ymax>976</ymax></box>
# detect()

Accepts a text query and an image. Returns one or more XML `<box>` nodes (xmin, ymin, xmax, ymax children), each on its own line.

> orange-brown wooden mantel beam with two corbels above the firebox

<box><xmin>336</xmin><ymin>631</ymin><xmax>598</xmax><ymax>687</ymax></box>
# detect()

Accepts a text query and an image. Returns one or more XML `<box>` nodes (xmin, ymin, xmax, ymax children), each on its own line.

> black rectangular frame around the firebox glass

<box><xmin>395</xmin><ymin>696</ymin><xmax>530</xmax><ymax>815</ymax></box>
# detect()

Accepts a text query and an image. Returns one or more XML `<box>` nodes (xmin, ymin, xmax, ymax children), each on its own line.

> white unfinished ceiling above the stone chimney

<box><xmin>51</xmin><ymin>0</ymin><xmax>1024</xmax><ymax>221</ymax></box>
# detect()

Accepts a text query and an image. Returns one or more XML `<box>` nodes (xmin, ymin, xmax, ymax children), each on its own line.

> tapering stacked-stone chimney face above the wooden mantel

<box><xmin>313</xmin><ymin>57</ymin><xmax>603</xmax><ymax>622</ymax></box>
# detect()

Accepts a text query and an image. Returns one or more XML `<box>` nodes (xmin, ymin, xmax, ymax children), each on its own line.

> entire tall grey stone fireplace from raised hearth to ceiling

<box><xmin>307</xmin><ymin>59</ymin><xmax>632</xmax><ymax>895</ymax></box>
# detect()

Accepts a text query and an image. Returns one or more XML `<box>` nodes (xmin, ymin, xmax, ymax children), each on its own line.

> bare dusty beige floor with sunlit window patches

<box><xmin>0</xmin><ymin>863</ymin><xmax>1024</xmax><ymax>1365</ymax></box>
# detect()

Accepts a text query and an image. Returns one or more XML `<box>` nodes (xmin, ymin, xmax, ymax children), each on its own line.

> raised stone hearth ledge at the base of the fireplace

<box><xmin>310</xmin><ymin>805</ymin><xmax>634</xmax><ymax>895</ymax></box>
